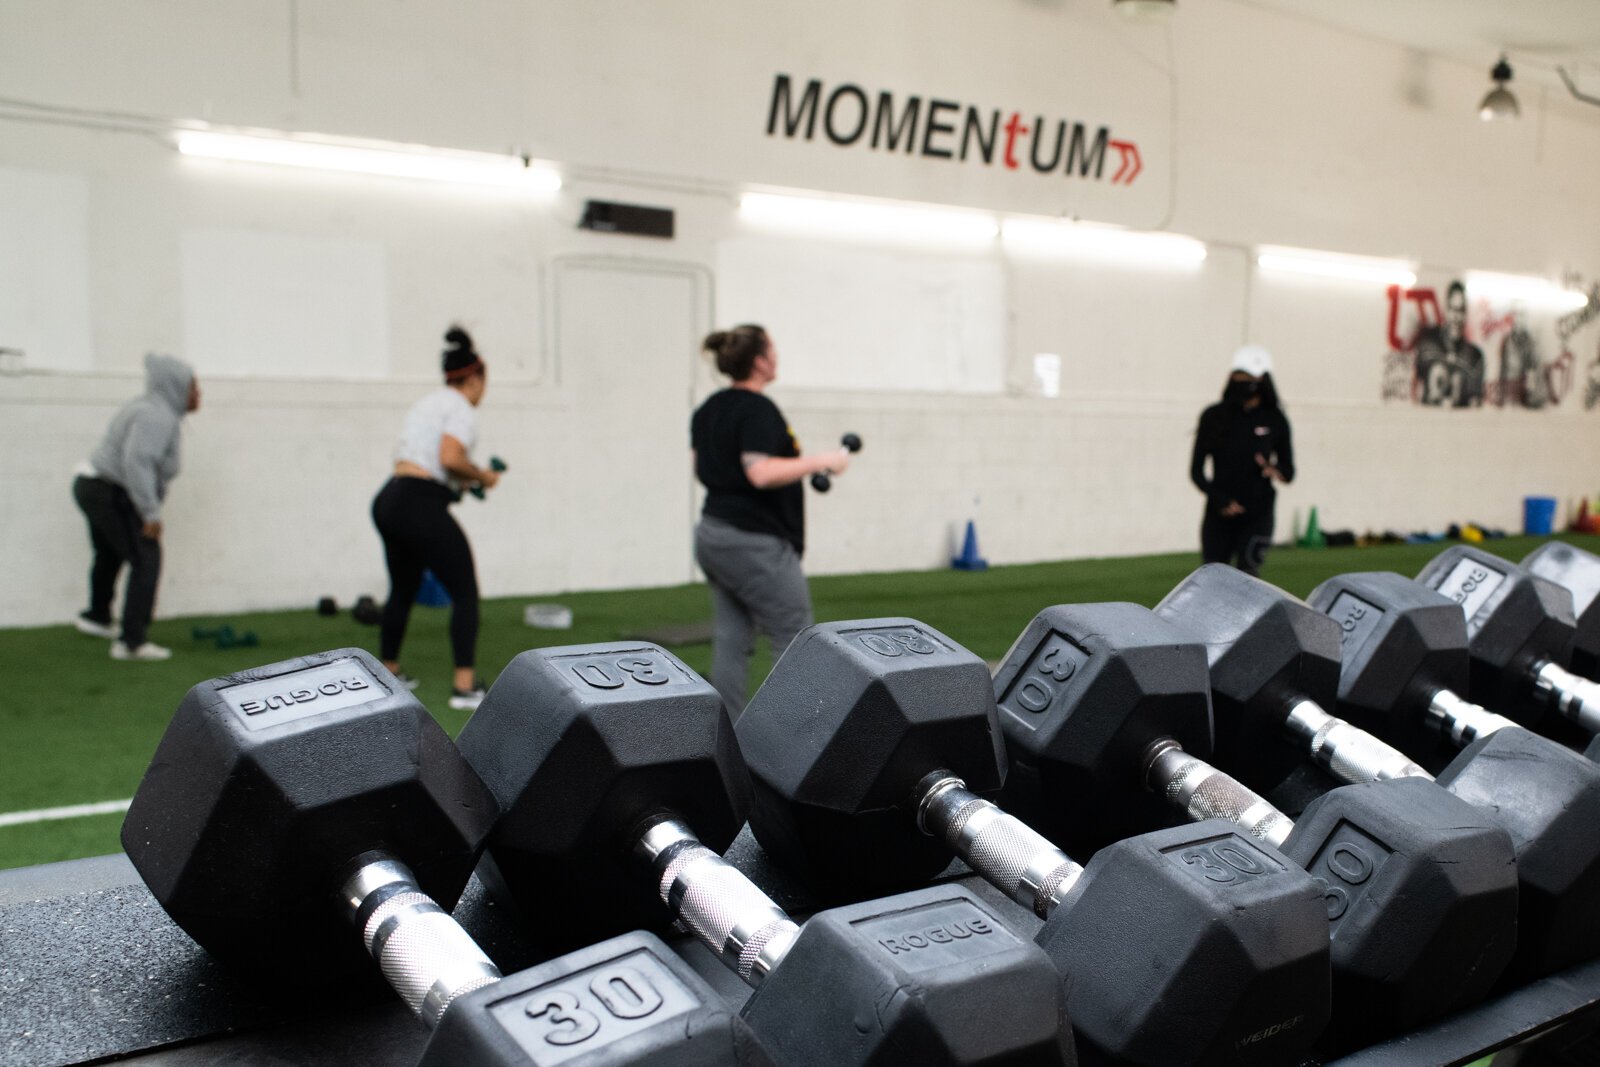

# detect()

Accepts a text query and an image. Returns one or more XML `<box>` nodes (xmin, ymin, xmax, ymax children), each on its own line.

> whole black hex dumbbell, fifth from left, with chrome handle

<box><xmin>1155</xmin><ymin>565</ymin><xmax>1600</xmax><ymax>981</ymax></box>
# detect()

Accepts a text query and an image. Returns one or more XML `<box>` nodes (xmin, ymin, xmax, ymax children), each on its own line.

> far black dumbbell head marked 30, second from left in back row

<box><xmin>456</xmin><ymin>641</ymin><xmax>749</xmax><ymax>942</ymax></box>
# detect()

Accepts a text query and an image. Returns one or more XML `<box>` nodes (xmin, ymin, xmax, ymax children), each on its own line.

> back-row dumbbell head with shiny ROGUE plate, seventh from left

<box><xmin>1416</xmin><ymin>544</ymin><xmax>1578</xmax><ymax>726</ymax></box>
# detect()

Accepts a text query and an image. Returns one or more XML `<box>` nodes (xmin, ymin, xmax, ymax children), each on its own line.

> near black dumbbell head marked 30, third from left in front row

<box><xmin>1037</xmin><ymin>819</ymin><xmax>1330</xmax><ymax>1067</ymax></box>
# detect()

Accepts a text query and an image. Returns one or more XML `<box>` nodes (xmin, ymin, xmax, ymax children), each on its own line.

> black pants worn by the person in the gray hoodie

<box><xmin>72</xmin><ymin>475</ymin><xmax>162</xmax><ymax>648</ymax></box>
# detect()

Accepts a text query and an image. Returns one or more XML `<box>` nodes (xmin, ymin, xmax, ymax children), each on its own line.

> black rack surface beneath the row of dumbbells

<box><xmin>0</xmin><ymin>832</ymin><xmax>1600</xmax><ymax>1067</ymax></box>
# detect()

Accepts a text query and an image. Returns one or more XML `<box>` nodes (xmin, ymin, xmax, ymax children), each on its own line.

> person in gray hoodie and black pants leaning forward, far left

<box><xmin>72</xmin><ymin>352</ymin><xmax>200</xmax><ymax>659</ymax></box>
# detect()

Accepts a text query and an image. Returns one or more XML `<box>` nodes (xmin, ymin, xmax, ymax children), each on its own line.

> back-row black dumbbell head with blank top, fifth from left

<box><xmin>1155</xmin><ymin>563</ymin><xmax>1339</xmax><ymax>789</ymax></box>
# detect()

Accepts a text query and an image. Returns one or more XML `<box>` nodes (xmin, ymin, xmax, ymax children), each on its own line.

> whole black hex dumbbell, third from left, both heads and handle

<box><xmin>736</xmin><ymin>617</ymin><xmax>1330</xmax><ymax>1067</ymax></box>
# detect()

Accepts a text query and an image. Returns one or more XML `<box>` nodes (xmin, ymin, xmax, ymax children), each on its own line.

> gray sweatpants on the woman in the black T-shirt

<box><xmin>694</xmin><ymin>517</ymin><xmax>811</xmax><ymax>718</ymax></box>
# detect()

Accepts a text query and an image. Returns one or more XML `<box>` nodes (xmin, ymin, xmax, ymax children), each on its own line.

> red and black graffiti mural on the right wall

<box><xmin>1382</xmin><ymin>282</ymin><xmax>1600</xmax><ymax>410</ymax></box>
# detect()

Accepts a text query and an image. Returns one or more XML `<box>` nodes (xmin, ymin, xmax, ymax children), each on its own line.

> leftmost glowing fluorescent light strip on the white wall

<box><xmin>178</xmin><ymin>131</ymin><xmax>562</xmax><ymax>194</ymax></box>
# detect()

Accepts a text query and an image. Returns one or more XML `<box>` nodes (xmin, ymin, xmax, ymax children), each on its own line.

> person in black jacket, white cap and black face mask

<box><xmin>1189</xmin><ymin>344</ymin><xmax>1294</xmax><ymax>574</ymax></box>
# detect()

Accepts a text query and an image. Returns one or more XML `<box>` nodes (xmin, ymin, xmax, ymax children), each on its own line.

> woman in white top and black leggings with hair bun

<box><xmin>373</xmin><ymin>326</ymin><xmax>499</xmax><ymax>710</ymax></box>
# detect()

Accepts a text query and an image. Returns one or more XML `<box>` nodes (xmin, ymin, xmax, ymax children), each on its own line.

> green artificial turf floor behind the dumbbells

<box><xmin>0</xmin><ymin>536</ymin><xmax>1600</xmax><ymax>867</ymax></box>
